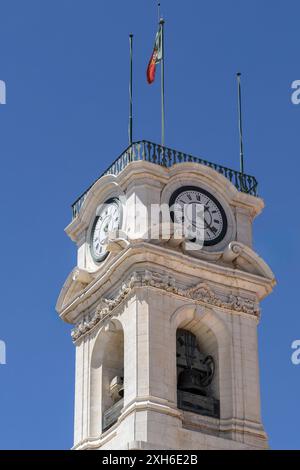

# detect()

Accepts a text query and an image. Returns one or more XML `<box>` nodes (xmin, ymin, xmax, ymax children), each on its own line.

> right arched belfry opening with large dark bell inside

<box><xmin>176</xmin><ymin>322</ymin><xmax>220</xmax><ymax>418</ymax></box>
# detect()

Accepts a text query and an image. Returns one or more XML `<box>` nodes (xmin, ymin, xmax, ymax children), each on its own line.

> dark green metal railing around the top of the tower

<box><xmin>72</xmin><ymin>140</ymin><xmax>257</xmax><ymax>219</ymax></box>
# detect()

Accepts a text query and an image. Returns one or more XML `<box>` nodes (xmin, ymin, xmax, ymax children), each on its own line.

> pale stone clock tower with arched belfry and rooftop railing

<box><xmin>57</xmin><ymin>141</ymin><xmax>275</xmax><ymax>450</ymax></box>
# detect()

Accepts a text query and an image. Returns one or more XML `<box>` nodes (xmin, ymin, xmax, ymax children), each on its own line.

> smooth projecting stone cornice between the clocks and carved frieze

<box><xmin>57</xmin><ymin>242</ymin><xmax>275</xmax><ymax>323</ymax></box>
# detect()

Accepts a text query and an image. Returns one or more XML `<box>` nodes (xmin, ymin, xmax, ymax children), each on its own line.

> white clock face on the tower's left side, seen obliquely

<box><xmin>90</xmin><ymin>198</ymin><xmax>122</xmax><ymax>261</ymax></box>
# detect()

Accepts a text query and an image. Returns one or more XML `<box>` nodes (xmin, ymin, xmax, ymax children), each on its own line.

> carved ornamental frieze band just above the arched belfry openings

<box><xmin>71</xmin><ymin>270</ymin><xmax>259</xmax><ymax>342</ymax></box>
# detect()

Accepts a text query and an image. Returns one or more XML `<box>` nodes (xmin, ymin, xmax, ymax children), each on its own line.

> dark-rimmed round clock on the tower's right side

<box><xmin>169</xmin><ymin>186</ymin><xmax>227</xmax><ymax>246</ymax></box>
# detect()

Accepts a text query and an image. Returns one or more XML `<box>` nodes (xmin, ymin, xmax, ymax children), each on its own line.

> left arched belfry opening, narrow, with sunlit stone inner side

<box><xmin>90</xmin><ymin>320</ymin><xmax>124</xmax><ymax>435</ymax></box>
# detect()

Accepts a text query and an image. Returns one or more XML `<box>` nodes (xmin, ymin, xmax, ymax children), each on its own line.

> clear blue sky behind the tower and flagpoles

<box><xmin>0</xmin><ymin>0</ymin><xmax>300</xmax><ymax>449</ymax></box>
